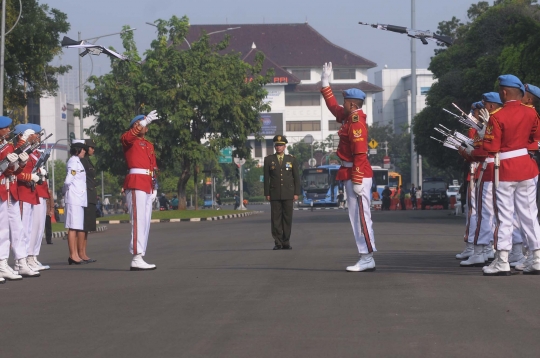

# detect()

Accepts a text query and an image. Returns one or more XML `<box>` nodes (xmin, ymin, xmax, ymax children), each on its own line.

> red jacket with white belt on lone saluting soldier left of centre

<box><xmin>121</xmin><ymin>124</ymin><xmax>157</xmax><ymax>194</ymax></box>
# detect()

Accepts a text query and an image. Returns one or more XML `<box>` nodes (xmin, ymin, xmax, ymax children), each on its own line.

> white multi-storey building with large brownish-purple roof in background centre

<box><xmin>183</xmin><ymin>23</ymin><xmax>382</xmax><ymax>164</ymax></box>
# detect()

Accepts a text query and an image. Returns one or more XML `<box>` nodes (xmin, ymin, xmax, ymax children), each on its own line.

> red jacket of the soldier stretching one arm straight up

<box><xmin>321</xmin><ymin>87</ymin><xmax>373</xmax><ymax>184</ymax></box>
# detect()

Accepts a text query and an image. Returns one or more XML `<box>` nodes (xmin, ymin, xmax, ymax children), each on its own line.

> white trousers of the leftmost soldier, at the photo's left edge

<box><xmin>0</xmin><ymin>195</ymin><xmax>28</xmax><ymax>260</ymax></box>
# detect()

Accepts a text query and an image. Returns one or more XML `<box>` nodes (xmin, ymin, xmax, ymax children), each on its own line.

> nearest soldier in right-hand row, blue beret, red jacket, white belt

<box><xmin>483</xmin><ymin>75</ymin><xmax>540</xmax><ymax>276</ymax></box>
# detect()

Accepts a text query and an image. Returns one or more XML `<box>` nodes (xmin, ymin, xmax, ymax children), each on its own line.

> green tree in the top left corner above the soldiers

<box><xmin>4</xmin><ymin>0</ymin><xmax>71</xmax><ymax>112</ymax></box>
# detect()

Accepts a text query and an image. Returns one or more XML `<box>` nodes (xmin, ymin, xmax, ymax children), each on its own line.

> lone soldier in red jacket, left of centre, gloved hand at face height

<box><xmin>121</xmin><ymin>111</ymin><xmax>158</xmax><ymax>271</ymax></box>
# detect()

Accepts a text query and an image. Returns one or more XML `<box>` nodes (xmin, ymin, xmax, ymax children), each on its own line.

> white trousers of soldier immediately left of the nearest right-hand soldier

<box><xmin>467</xmin><ymin>182</ymin><xmax>494</xmax><ymax>245</ymax></box>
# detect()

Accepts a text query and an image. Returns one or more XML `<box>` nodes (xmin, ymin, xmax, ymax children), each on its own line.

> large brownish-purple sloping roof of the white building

<box><xmin>182</xmin><ymin>23</ymin><xmax>377</xmax><ymax>68</ymax></box>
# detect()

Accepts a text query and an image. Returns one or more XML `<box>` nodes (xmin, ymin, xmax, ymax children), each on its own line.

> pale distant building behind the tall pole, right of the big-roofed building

<box><xmin>373</xmin><ymin>68</ymin><xmax>436</xmax><ymax>133</ymax></box>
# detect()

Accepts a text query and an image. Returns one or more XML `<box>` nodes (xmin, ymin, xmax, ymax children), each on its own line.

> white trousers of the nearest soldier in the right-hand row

<box><xmin>493</xmin><ymin>178</ymin><xmax>540</xmax><ymax>251</ymax></box>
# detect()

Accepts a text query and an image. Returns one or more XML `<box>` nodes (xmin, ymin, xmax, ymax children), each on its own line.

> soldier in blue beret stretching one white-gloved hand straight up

<box><xmin>321</xmin><ymin>62</ymin><xmax>376</xmax><ymax>272</ymax></box>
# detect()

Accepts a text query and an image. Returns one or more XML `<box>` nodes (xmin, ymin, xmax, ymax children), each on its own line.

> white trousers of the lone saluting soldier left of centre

<box><xmin>126</xmin><ymin>189</ymin><xmax>154</xmax><ymax>256</ymax></box>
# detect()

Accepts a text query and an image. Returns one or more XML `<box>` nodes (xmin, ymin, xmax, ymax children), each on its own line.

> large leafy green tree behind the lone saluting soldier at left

<box><xmin>87</xmin><ymin>16</ymin><xmax>272</xmax><ymax>208</ymax></box>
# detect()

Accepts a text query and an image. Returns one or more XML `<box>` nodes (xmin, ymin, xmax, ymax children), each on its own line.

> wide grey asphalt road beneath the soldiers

<box><xmin>0</xmin><ymin>206</ymin><xmax>540</xmax><ymax>358</ymax></box>
